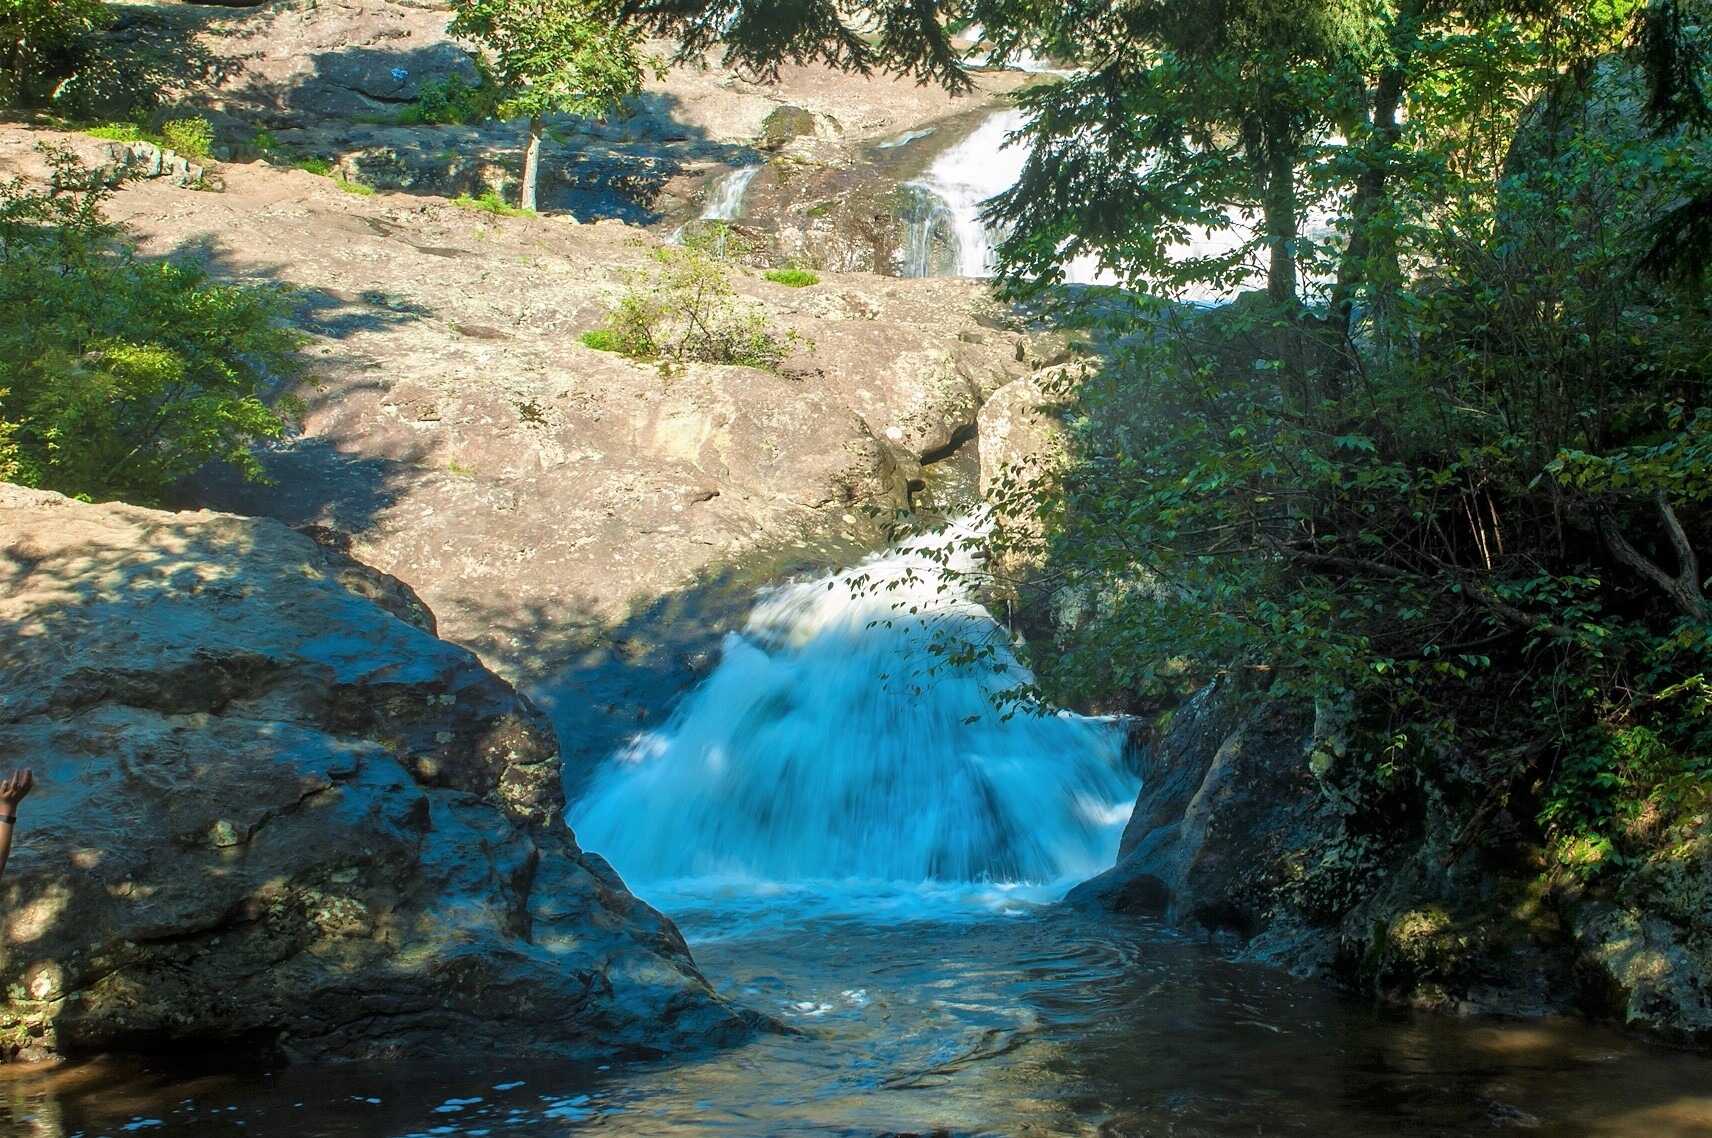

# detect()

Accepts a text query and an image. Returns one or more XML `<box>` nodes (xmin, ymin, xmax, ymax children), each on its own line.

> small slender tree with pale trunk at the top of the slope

<box><xmin>449</xmin><ymin>0</ymin><xmax>657</xmax><ymax>209</ymax></box>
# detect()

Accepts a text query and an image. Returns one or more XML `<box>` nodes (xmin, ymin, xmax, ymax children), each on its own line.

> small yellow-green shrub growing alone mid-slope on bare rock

<box><xmin>586</xmin><ymin>246</ymin><xmax>798</xmax><ymax>371</ymax></box>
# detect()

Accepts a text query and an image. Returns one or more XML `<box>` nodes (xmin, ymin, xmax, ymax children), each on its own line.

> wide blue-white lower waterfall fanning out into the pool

<box><xmin>570</xmin><ymin>524</ymin><xmax>1137</xmax><ymax>892</ymax></box>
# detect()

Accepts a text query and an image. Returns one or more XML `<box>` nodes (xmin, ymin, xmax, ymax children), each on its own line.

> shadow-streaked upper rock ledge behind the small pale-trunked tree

<box><xmin>106</xmin><ymin>0</ymin><xmax>1022</xmax><ymax>222</ymax></box>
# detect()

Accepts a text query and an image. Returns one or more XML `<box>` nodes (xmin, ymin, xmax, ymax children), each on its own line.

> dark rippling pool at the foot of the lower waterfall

<box><xmin>0</xmin><ymin>893</ymin><xmax>1712</xmax><ymax>1138</ymax></box>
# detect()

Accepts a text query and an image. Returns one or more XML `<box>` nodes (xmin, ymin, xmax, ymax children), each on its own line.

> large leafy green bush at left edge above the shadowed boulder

<box><xmin>0</xmin><ymin>151</ymin><xmax>298</xmax><ymax>503</ymax></box>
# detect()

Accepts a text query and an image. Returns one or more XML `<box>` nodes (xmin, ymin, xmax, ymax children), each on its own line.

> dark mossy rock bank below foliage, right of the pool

<box><xmin>1070</xmin><ymin>678</ymin><xmax>1712</xmax><ymax>1046</ymax></box>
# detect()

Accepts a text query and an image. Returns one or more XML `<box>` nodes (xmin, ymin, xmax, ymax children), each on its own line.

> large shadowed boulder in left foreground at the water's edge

<box><xmin>0</xmin><ymin>484</ymin><xmax>746</xmax><ymax>1059</ymax></box>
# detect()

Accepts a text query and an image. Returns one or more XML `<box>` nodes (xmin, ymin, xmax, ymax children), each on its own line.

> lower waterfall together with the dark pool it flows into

<box><xmin>0</xmin><ymin>524</ymin><xmax>1712</xmax><ymax>1138</ymax></box>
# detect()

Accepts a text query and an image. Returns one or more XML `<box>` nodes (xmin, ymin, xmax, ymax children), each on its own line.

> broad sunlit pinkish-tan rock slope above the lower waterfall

<box><xmin>0</xmin><ymin>128</ymin><xmax>1037</xmax><ymax>780</ymax></box>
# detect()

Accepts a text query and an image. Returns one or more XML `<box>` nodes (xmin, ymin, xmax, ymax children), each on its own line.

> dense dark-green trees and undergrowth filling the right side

<box><xmin>635</xmin><ymin>0</ymin><xmax>1712</xmax><ymax>873</ymax></box>
